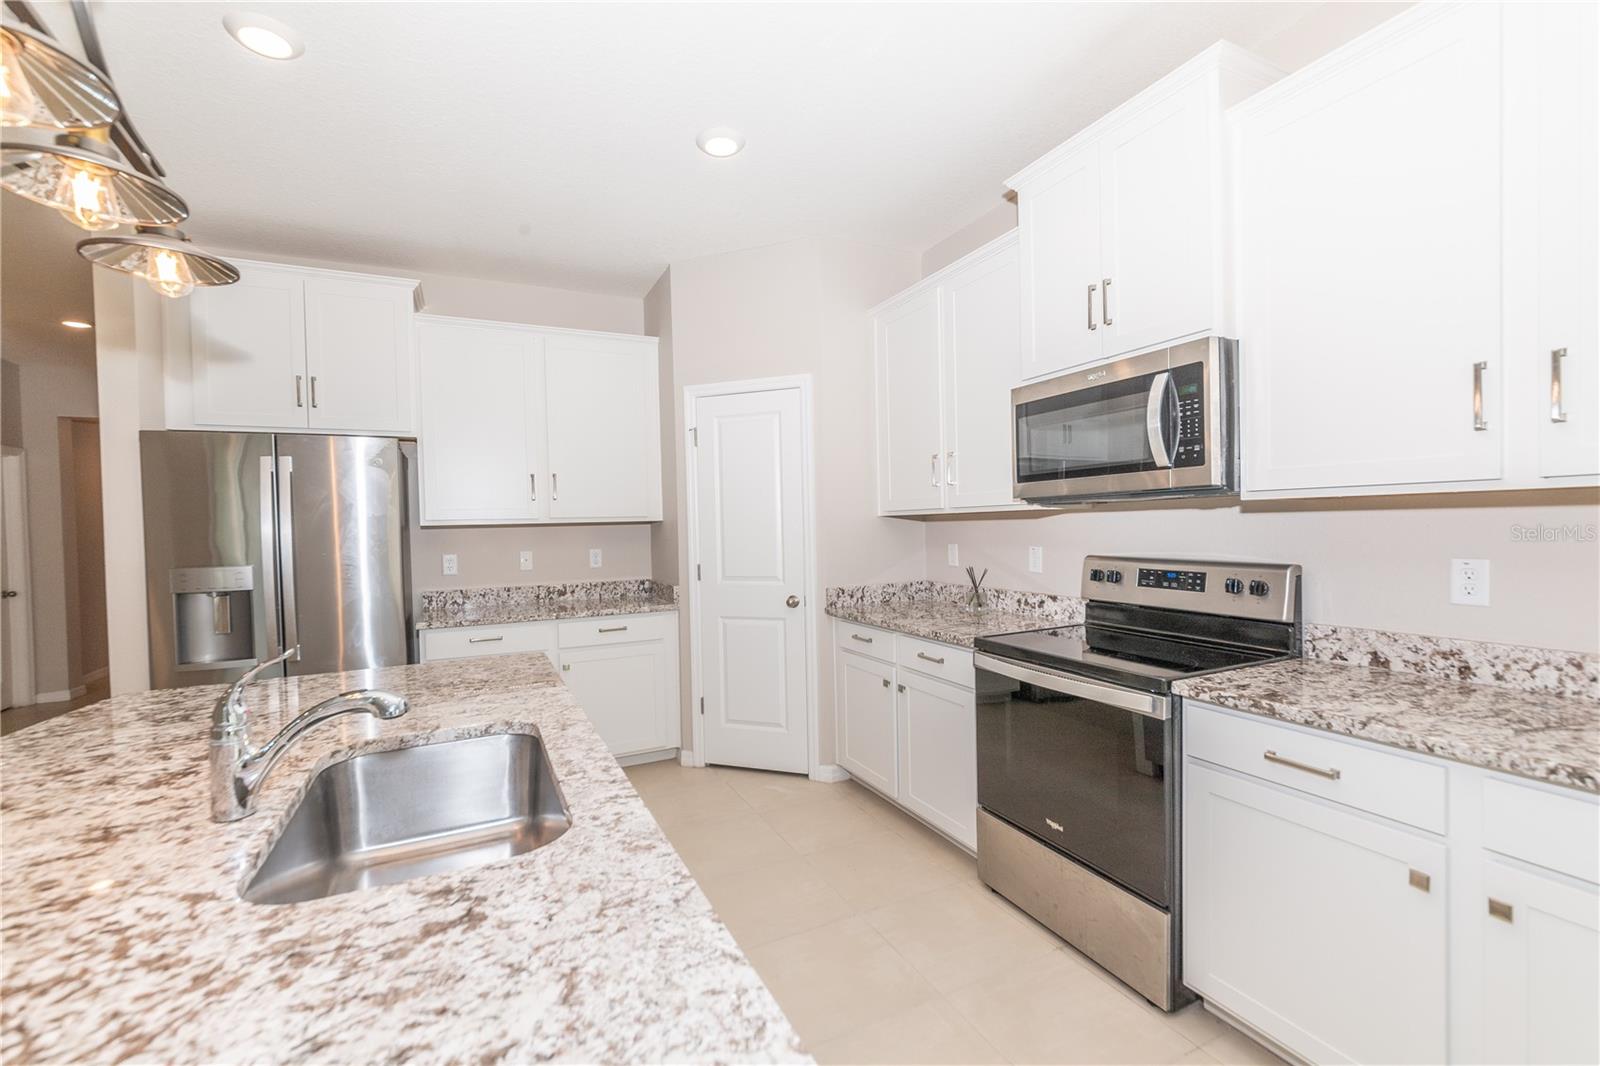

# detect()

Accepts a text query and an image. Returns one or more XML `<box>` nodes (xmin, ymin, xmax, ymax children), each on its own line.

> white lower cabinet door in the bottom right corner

<box><xmin>1478</xmin><ymin>860</ymin><xmax>1600</xmax><ymax>1063</ymax></box>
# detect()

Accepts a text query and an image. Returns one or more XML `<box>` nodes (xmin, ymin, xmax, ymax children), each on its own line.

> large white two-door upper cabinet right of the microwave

<box><xmin>1230</xmin><ymin>3</ymin><xmax>1600</xmax><ymax>498</ymax></box>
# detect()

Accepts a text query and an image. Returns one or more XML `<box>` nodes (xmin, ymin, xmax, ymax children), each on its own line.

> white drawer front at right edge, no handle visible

<box><xmin>1483</xmin><ymin>778</ymin><xmax>1600</xmax><ymax>884</ymax></box>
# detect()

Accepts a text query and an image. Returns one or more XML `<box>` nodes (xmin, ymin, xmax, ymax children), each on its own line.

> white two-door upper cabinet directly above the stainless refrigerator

<box><xmin>180</xmin><ymin>261</ymin><xmax>416</xmax><ymax>434</ymax></box>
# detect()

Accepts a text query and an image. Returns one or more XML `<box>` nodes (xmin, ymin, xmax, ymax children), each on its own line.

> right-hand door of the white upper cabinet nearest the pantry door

<box><xmin>544</xmin><ymin>333</ymin><xmax>661</xmax><ymax>520</ymax></box>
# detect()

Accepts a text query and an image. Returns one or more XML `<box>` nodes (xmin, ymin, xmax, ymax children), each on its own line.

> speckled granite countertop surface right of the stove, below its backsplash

<box><xmin>1173</xmin><ymin>659</ymin><xmax>1600</xmax><ymax>792</ymax></box>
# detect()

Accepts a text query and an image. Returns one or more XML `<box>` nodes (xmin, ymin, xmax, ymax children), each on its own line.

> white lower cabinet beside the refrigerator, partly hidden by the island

<box><xmin>421</xmin><ymin>615</ymin><xmax>682</xmax><ymax>757</ymax></box>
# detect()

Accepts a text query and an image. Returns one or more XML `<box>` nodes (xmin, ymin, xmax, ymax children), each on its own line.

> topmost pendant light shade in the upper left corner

<box><xmin>0</xmin><ymin>18</ymin><xmax>122</xmax><ymax>130</ymax></box>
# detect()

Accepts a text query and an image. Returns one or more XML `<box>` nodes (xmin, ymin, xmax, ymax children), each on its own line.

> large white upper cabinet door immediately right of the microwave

<box><xmin>1232</xmin><ymin>3</ymin><xmax>1504</xmax><ymax>493</ymax></box>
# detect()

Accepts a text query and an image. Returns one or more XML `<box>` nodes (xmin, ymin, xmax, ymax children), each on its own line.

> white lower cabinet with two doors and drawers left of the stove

<box><xmin>834</xmin><ymin>621</ymin><xmax>978</xmax><ymax>850</ymax></box>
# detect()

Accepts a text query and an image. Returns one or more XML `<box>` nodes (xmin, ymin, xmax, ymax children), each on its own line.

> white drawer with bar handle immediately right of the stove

<box><xmin>1184</xmin><ymin>703</ymin><xmax>1445</xmax><ymax>834</ymax></box>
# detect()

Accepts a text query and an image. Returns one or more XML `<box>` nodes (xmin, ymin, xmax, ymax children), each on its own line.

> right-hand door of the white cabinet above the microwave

<box><xmin>1099</xmin><ymin>78</ymin><xmax>1219</xmax><ymax>357</ymax></box>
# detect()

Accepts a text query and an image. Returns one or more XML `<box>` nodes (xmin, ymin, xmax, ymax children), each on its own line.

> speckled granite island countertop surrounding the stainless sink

<box><xmin>0</xmin><ymin>653</ymin><xmax>808</xmax><ymax>1063</ymax></box>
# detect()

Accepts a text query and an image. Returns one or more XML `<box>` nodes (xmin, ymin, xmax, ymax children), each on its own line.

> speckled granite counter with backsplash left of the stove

<box><xmin>827</xmin><ymin>581</ymin><xmax>1083</xmax><ymax>648</ymax></box>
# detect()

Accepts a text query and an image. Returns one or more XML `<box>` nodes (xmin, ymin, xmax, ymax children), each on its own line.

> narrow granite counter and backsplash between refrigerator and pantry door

<box><xmin>416</xmin><ymin>578</ymin><xmax>678</xmax><ymax>629</ymax></box>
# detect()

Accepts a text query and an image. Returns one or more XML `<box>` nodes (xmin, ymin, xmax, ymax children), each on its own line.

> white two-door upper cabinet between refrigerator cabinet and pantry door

<box><xmin>416</xmin><ymin>315</ymin><xmax>661</xmax><ymax>525</ymax></box>
